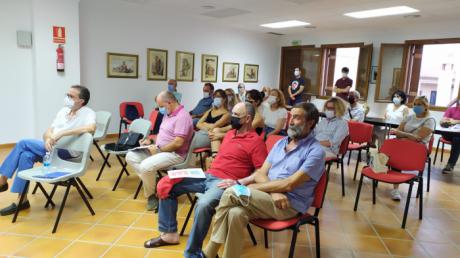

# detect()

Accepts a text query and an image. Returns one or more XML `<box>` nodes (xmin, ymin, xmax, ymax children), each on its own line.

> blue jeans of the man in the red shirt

<box><xmin>158</xmin><ymin>174</ymin><xmax>224</xmax><ymax>258</ymax></box>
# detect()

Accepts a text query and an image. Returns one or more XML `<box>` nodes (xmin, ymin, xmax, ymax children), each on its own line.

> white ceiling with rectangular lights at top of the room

<box><xmin>112</xmin><ymin>0</ymin><xmax>460</xmax><ymax>34</ymax></box>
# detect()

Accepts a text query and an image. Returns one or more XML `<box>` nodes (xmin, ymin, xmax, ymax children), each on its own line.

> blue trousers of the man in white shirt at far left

<box><xmin>0</xmin><ymin>139</ymin><xmax>46</xmax><ymax>193</ymax></box>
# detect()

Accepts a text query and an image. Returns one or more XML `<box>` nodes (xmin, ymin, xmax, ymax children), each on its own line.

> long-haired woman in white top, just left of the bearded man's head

<box><xmin>262</xmin><ymin>89</ymin><xmax>287</xmax><ymax>136</ymax></box>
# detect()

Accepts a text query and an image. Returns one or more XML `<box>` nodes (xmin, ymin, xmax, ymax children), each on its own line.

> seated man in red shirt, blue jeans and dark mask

<box><xmin>144</xmin><ymin>103</ymin><xmax>267</xmax><ymax>257</ymax></box>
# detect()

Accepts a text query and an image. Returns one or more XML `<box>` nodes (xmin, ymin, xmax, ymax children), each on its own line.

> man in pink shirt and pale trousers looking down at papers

<box><xmin>126</xmin><ymin>91</ymin><xmax>193</xmax><ymax>211</ymax></box>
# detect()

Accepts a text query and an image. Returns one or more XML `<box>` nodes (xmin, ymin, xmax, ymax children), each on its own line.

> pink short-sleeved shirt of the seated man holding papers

<box><xmin>156</xmin><ymin>105</ymin><xmax>193</xmax><ymax>158</ymax></box>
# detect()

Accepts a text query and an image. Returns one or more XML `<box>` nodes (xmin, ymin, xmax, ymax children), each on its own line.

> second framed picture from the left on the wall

<box><xmin>147</xmin><ymin>48</ymin><xmax>168</xmax><ymax>81</ymax></box>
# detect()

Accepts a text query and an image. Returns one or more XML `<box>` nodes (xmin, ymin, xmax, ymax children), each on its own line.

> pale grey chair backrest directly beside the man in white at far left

<box><xmin>51</xmin><ymin>133</ymin><xmax>93</xmax><ymax>177</ymax></box>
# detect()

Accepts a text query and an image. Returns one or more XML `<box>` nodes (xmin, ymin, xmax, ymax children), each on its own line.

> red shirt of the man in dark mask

<box><xmin>208</xmin><ymin>130</ymin><xmax>267</xmax><ymax>180</ymax></box>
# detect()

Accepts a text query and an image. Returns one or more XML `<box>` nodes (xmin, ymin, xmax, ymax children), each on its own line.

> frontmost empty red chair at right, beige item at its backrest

<box><xmin>354</xmin><ymin>139</ymin><xmax>427</xmax><ymax>228</ymax></box>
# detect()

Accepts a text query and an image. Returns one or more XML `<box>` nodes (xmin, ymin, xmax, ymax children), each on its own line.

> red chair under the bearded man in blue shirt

<box><xmin>247</xmin><ymin>171</ymin><xmax>329</xmax><ymax>258</ymax></box>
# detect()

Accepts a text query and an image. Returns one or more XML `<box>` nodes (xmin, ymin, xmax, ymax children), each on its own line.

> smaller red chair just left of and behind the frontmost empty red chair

<box><xmin>347</xmin><ymin>121</ymin><xmax>374</xmax><ymax>180</ymax></box>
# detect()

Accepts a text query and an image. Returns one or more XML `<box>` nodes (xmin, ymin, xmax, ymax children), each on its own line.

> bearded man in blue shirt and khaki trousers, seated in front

<box><xmin>203</xmin><ymin>103</ymin><xmax>324</xmax><ymax>258</ymax></box>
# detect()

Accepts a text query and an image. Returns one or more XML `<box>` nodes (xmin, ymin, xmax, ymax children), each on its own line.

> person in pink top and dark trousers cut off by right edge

<box><xmin>441</xmin><ymin>99</ymin><xmax>460</xmax><ymax>174</ymax></box>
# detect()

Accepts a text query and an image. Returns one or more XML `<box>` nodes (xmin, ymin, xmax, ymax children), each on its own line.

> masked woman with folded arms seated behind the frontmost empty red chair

<box><xmin>391</xmin><ymin>96</ymin><xmax>436</xmax><ymax>201</ymax></box>
